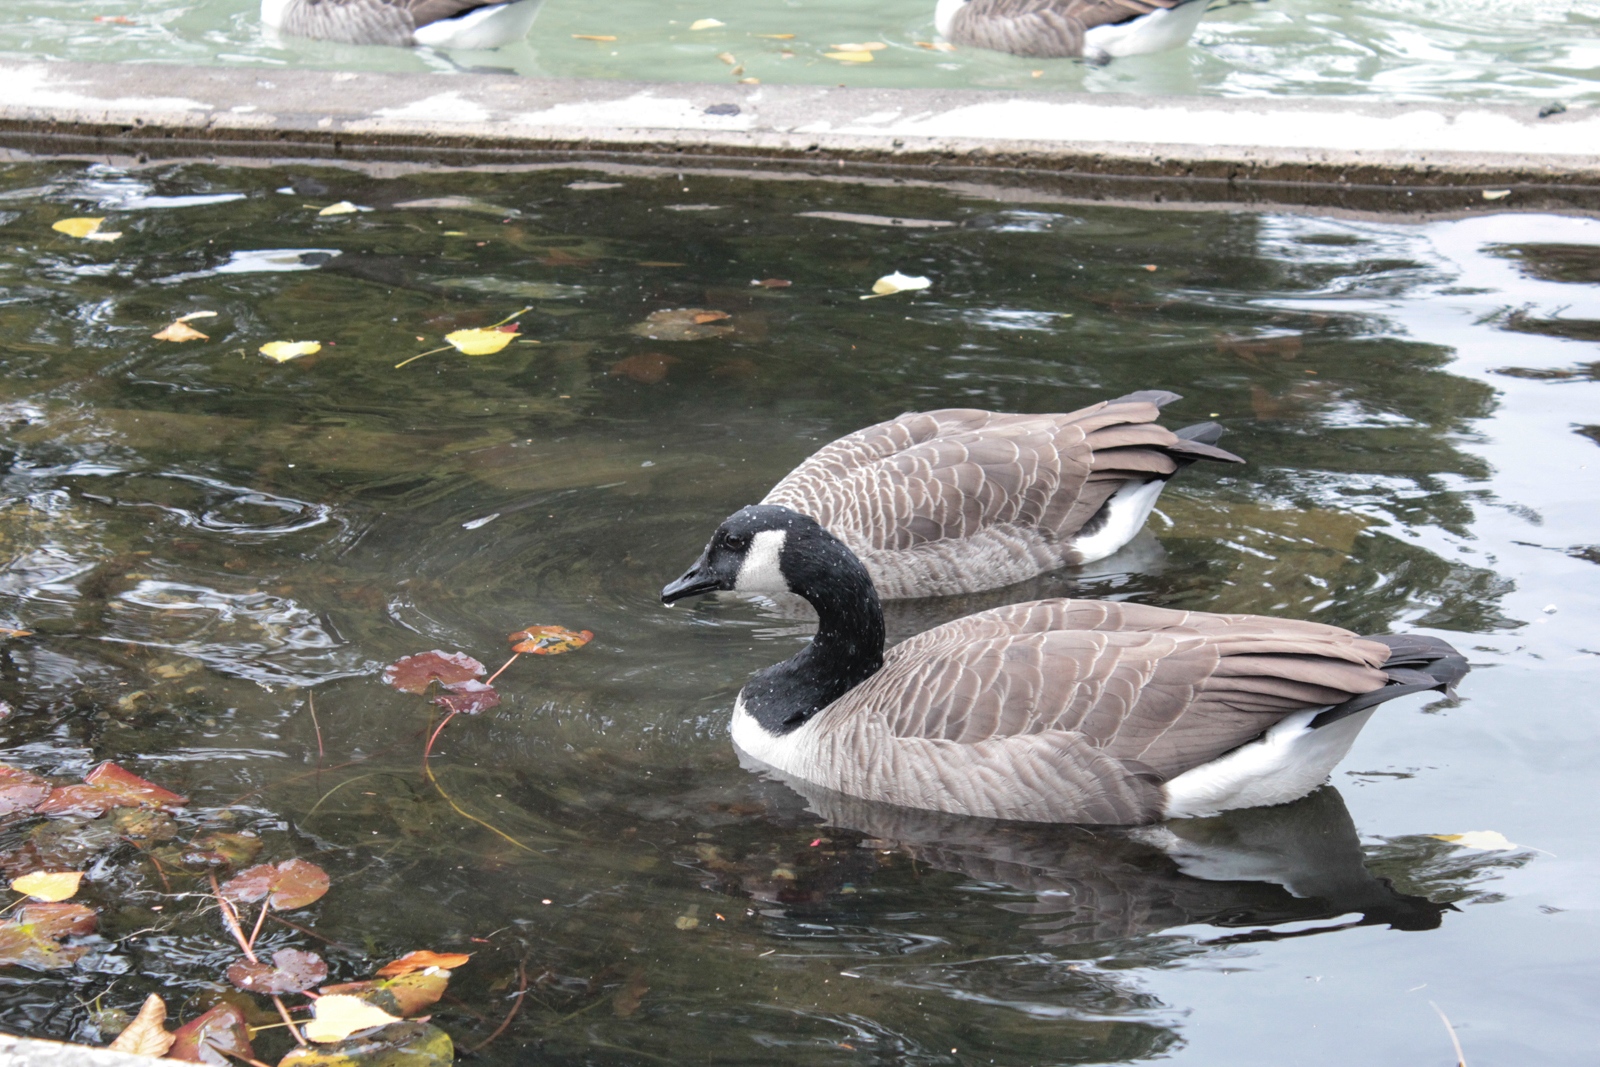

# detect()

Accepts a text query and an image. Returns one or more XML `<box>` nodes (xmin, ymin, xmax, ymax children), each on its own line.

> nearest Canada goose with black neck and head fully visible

<box><xmin>661</xmin><ymin>504</ymin><xmax>1467</xmax><ymax>824</ymax></box>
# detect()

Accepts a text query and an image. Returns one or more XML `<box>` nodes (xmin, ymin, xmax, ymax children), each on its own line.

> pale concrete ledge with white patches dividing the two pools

<box><xmin>0</xmin><ymin>61</ymin><xmax>1600</xmax><ymax>213</ymax></box>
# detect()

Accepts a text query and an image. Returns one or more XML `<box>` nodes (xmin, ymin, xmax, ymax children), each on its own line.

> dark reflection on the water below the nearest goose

<box><xmin>718</xmin><ymin>776</ymin><xmax>1456</xmax><ymax>945</ymax></box>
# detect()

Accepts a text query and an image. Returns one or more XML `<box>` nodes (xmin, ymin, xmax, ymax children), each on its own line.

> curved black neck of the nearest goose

<box><xmin>739</xmin><ymin>526</ymin><xmax>883</xmax><ymax>736</ymax></box>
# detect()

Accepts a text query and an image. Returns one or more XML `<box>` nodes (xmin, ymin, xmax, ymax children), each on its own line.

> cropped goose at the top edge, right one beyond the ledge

<box><xmin>933</xmin><ymin>0</ymin><xmax>1206</xmax><ymax>62</ymax></box>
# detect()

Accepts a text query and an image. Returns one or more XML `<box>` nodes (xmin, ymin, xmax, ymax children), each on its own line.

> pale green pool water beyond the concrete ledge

<box><xmin>0</xmin><ymin>0</ymin><xmax>1600</xmax><ymax>106</ymax></box>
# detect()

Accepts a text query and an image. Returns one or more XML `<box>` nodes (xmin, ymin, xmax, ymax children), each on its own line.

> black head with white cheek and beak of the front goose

<box><xmin>661</xmin><ymin>504</ymin><xmax>819</xmax><ymax>605</ymax></box>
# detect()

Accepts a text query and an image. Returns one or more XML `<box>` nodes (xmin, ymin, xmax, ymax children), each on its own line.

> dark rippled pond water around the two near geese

<box><xmin>0</xmin><ymin>160</ymin><xmax>1600</xmax><ymax>1067</ymax></box>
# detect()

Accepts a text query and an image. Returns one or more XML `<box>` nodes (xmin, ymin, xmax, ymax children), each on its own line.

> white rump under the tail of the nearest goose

<box><xmin>1165</xmin><ymin>707</ymin><xmax>1378</xmax><ymax>819</ymax></box>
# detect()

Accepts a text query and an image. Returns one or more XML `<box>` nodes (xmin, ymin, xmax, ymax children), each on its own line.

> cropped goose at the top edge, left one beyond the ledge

<box><xmin>261</xmin><ymin>0</ymin><xmax>544</xmax><ymax>48</ymax></box>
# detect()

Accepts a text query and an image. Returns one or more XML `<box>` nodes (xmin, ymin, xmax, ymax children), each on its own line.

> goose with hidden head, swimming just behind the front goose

<box><xmin>762</xmin><ymin>389</ymin><xmax>1245</xmax><ymax>600</ymax></box>
